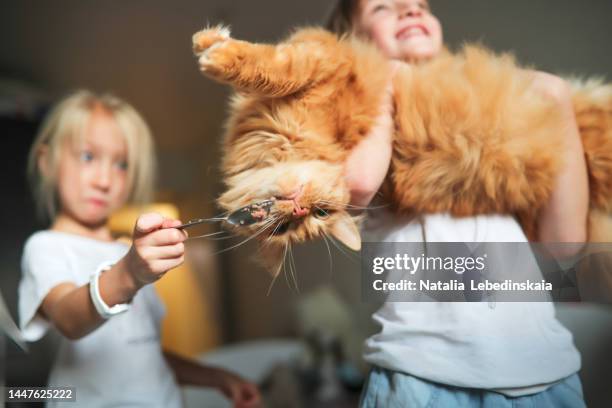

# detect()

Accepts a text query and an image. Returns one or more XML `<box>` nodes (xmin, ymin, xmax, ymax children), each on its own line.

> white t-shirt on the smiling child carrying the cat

<box><xmin>363</xmin><ymin>212</ymin><xmax>580</xmax><ymax>396</ymax></box>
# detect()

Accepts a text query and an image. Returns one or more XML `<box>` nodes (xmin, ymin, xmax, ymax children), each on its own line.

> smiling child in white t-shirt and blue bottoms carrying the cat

<box><xmin>330</xmin><ymin>0</ymin><xmax>588</xmax><ymax>407</ymax></box>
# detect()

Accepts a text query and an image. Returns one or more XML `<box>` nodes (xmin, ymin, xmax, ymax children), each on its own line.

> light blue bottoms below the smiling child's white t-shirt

<box><xmin>359</xmin><ymin>368</ymin><xmax>586</xmax><ymax>408</ymax></box>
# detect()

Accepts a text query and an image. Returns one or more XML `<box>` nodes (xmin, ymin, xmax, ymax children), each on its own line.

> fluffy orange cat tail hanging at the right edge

<box><xmin>570</xmin><ymin>79</ymin><xmax>612</xmax><ymax>242</ymax></box>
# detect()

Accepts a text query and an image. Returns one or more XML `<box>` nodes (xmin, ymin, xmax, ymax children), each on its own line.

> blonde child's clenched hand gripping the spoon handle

<box><xmin>124</xmin><ymin>213</ymin><xmax>187</xmax><ymax>287</ymax></box>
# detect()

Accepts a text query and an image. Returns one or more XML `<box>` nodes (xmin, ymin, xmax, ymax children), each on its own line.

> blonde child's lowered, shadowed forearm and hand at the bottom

<box><xmin>164</xmin><ymin>351</ymin><xmax>261</xmax><ymax>408</ymax></box>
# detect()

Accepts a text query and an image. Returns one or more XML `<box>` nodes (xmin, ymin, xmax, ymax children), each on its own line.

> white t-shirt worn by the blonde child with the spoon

<box><xmin>19</xmin><ymin>231</ymin><xmax>182</xmax><ymax>408</ymax></box>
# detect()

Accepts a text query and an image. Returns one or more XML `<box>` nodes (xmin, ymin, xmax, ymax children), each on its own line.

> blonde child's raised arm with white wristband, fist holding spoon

<box><xmin>40</xmin><ymin>214</ymin><xmax>185</xmax><ymax>340</ymax></box>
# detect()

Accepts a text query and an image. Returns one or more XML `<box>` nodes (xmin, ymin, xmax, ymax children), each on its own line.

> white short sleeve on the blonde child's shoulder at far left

<box><xmin>18</xmin><ymin>232</ymin><xmax>76</xmax><ymax>341</ymax></box>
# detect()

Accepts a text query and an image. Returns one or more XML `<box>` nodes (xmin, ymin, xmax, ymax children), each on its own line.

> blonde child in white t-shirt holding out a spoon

<box><xmin>19</xmin><ymin>91</ymin><xmax>260</xmax><ymax>408</ymax></box>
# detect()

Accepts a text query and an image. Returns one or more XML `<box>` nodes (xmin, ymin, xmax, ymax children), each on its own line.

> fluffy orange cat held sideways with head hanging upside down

<box><xmin>193</xmin><ymin>27</ymin><xmax>612</xmax><ymax>275</ymax></box>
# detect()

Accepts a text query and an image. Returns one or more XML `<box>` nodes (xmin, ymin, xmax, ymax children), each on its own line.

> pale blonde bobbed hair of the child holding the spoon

<box><xmin>28</xmin><ymin>90</ymin><xmax>156</xmax><ymax>221</ymax></box>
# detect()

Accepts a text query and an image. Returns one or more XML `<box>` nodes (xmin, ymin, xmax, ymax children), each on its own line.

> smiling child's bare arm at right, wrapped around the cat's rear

<box><xmin>532</xmin><ymin>72</ymin><xmax>589</xmax><ymax>256</ymax></box>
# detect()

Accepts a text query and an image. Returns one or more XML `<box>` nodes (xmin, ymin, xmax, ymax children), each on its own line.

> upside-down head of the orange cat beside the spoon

<box><xmin>218</xmin><ymin>160</ymin><xmax>361</xmax><ymax>276</ymax></box>
